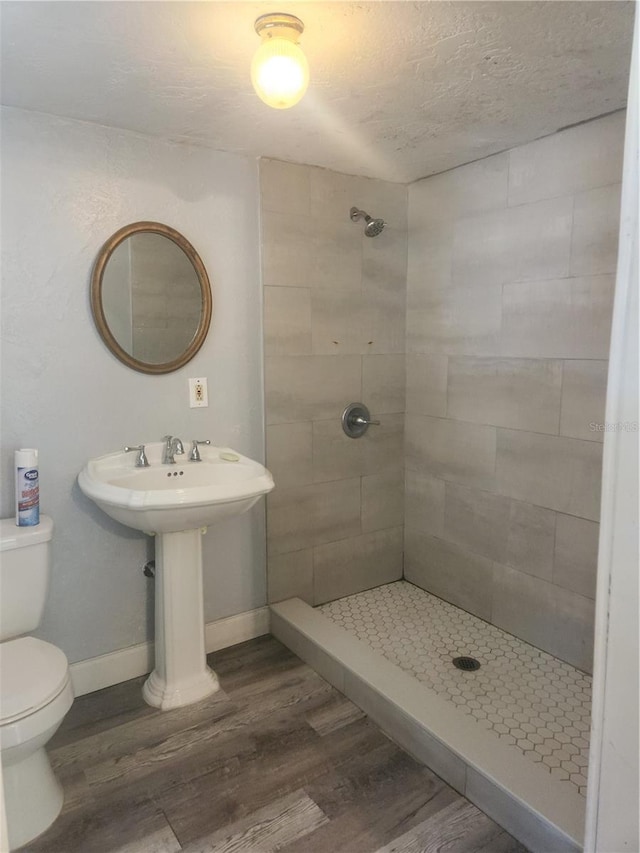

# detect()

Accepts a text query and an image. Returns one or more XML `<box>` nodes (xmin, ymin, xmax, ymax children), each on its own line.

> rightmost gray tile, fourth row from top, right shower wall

<box><xmin>560</xmin><ymin>361</ymin><xmax>609</xmax><ymax>441</ymax></box>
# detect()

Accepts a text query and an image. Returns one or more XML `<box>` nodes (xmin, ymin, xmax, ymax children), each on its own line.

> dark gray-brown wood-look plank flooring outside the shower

<box><xmin>23</xmin><ymin>637</ymin><xmax>526</xmax><ymax>853</ymax></box>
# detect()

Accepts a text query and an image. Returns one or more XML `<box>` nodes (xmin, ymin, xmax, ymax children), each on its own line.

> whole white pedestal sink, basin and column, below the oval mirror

<box><xmin>78</xmin><ymin>442</ymin><xmax>274</xmax><ymax>710</ymax></box>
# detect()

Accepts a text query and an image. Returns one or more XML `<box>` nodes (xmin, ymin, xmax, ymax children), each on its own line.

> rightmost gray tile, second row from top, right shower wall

<box><xmin>571</xmin><ymin>184</ymin><xmax>621</xmax><ymax>275</ymax></box>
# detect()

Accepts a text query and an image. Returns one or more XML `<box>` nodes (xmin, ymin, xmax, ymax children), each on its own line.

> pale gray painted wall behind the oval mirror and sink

<box><xmin>0</xmin><ymin>109</ymin><xmax>266</xmax><ymax>661</ymax></box>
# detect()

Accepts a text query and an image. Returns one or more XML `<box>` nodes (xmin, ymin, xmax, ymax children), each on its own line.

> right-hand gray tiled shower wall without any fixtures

<box><xmin>405</xmin><ymin>113</ymin><xmax>624</xmax><ymax>670</ymax></box>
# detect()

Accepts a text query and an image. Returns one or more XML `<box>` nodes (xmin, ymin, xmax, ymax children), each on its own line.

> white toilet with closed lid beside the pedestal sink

<box><xmin>0</xmin><ymin>515</ymin><xmax>73</xmax><ymax>850</ymax></box>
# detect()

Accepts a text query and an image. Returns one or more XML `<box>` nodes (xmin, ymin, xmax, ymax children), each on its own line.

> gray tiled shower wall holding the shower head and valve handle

<box><xmin>260</xmin><ymin>160</ymin><xmax>407</xmax><ymax>604</ymax></box>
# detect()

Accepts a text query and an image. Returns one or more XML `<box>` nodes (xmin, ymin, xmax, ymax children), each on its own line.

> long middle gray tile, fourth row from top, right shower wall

<box><xmin>447</xmin><ymin>358</ymin><xmax>562</xmax><ymax>434</ymax></box>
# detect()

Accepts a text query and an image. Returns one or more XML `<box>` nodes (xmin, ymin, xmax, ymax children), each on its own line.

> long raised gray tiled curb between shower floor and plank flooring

<box><xmin>270</xmin><ymin>598</ymin><xmax>585</xmax><ymax>853</ymax></box>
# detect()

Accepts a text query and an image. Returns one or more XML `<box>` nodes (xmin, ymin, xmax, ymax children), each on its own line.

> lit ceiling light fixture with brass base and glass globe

<box><xmin>251</xmin><ymin>12</ymin><xmax>309</xmax><ymax>110</ymax></box>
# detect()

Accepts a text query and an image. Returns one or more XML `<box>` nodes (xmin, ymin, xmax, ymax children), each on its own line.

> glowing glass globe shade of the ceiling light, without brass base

<box><xmin>251</xmin><ymin>37</ymin><xmax>309</xmax><ymax>110</ymax></box>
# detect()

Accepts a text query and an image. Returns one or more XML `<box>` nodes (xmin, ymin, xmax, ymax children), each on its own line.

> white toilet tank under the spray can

<box><xmin>0</xmin><ymin>515</ymin><xmax>53</xmax><ymax>640</ymax></box>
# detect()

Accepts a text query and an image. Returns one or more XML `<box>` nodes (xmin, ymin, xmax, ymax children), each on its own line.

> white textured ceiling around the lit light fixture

<box><xmin>1</xmin><ymin>0</ymin><xmax>633</xmax><ymax>181</ymax></box>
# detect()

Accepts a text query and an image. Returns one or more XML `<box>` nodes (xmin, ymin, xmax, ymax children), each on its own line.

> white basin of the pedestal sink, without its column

<box><xmin>78</xmin><ymin>441</ymin><xmax>274</xmax><ymax>533</ymax></box>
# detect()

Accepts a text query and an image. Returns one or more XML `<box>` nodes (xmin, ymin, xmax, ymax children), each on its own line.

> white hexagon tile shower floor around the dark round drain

<box><xmin>318</xmin><ymin>581</ymin><xmax>591</xmax><ymax>796</ymax></box>
